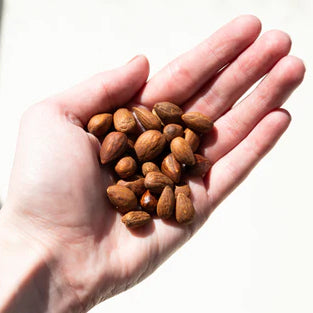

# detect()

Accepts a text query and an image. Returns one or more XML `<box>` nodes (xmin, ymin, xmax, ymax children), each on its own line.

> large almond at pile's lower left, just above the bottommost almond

<box><xmin>107</xmin><ymin>185</ymin><xmax>137</xmax><ymax>214</ymax></box>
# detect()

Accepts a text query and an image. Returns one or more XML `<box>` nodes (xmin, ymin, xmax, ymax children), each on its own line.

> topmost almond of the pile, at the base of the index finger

<box><xmin>153</xmin><ymin>102</ymin><xmax>184</xmax><ymax>125</ymax></box>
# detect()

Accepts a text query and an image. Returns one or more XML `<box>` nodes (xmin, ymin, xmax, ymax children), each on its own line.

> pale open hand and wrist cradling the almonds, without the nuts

<box><xmin>0</xmin><ymin>16</ymin><xmax>305</xmax><ymax>313</ymax></box>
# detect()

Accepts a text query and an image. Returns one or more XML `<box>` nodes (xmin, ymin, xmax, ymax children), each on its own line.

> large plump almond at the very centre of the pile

<box><xmin>135</xmin><ymin>130</ymin><xmax>166</xmax><ymax>162</ymax></box>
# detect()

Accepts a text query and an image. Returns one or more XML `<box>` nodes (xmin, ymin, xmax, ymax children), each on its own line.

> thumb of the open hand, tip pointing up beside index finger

<box><xmin>54</xmin><ymin>55</ymin><xmax>149</xmax><ymax>125</ymax></box>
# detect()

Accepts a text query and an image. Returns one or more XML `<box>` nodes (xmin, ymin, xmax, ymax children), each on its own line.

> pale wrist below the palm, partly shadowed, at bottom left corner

<box><xmin>0</xmin><ymin>207</ymin><xmax>83</xmax><ymax>313</ymax></box>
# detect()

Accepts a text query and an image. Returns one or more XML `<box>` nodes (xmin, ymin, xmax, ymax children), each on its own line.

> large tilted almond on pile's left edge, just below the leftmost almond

<box><xmin>100</xmin><ymin>132</ymin><xmax>128</xmax><ymax>164</ymax></box>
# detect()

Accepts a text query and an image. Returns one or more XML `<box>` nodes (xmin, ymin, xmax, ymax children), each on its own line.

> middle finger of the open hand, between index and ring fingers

<box><xmin>184</xmin><ymin>30</ymin><xmax>291</xmax><ymax>120</ymax></box>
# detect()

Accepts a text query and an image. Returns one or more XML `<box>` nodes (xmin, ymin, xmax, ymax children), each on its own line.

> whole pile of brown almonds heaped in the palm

<box><xmin>87</xmin><ymin>102</ymin><xmax>213</xmax><ymax>228</ymax></box>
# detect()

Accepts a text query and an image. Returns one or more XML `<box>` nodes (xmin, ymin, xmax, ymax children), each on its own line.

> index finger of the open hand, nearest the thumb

<box><xmin>136</xmin><ymin>15</ymin><xmax>261</xmax><ymax>106</ymax></box>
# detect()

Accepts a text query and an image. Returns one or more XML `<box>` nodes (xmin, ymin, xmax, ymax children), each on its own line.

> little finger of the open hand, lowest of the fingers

<box><xmin>206</xmin><ymin>109</ymin><xmax>291</xmax><ymax>210</ymax></box>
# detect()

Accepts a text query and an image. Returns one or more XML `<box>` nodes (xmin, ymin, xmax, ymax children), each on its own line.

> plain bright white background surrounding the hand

<box><xmin>0</xmin><ymin>0</ymin><xmax>313</xmax><ymax>313</ymax></box>
